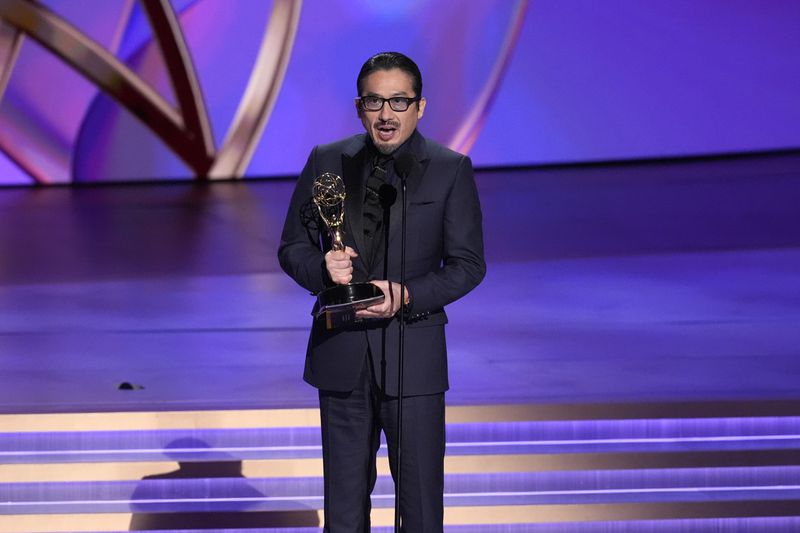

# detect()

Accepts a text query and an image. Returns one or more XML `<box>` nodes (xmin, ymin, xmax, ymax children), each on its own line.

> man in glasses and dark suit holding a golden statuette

<box><xmin>278</xmin><ymin>52</ymin><xmax>486</xmax><ymax>533</ymax></box>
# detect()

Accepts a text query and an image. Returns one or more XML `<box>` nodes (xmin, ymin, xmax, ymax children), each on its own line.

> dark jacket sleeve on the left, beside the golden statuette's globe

<box><xmin>278</xmin><ymin>148</ymin><xmax>333</xmax><ymax>294</ymax></box>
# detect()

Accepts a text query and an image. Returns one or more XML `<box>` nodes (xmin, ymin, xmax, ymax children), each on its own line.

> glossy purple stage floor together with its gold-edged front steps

<box><xmin>0</xmin><ymin>153</ymin><xmax>800</xmax><ymax>533</ymax></box>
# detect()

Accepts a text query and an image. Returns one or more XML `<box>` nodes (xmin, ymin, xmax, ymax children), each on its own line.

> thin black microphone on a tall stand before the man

<box><xmin>394</xmin><ymin>152</ymin><xmax>420</xmax><ymax>533</ymax></box>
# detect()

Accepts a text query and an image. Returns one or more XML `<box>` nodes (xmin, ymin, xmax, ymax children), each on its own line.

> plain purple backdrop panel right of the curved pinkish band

<box><xmin>472</xmin><ymin>0</ymin><xmax>800</xmax><ymax>165</ymax></box>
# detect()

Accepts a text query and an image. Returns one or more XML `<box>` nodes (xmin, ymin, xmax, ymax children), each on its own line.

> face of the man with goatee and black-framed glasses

<box><xmin>356</xmin><ymin>68</ymin><xmax>425</xmax><ymax>154</ymax></box>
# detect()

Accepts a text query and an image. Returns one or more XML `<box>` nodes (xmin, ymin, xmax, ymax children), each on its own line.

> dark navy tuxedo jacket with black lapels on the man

<box><xmin>278</xmin><ymin>132</ymin><xmax>486</xmax><ymax>396</ymax></box>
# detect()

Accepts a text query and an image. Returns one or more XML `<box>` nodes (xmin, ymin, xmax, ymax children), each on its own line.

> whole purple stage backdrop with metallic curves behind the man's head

<box><xmin>0</xmin><ymin>0</ymin><xmax>800</xmax><ymax>185</ymax></box>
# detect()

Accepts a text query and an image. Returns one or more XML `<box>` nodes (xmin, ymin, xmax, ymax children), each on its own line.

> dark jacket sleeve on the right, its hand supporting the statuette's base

<box><xmin>407</xmin><ymin>155</ymin><xmax>486</xmax><ymax>315</ymax></box>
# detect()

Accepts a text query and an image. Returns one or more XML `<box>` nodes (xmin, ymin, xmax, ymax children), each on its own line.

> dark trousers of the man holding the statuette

<box><xmin>319</xmin><ymin>357</ymin><xmax>445</xmax><ymax>533</ymax></box>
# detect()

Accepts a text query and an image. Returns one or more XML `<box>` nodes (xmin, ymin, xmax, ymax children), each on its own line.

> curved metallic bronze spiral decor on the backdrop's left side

<box><xmin>0</xmin><ymin>0</ymin><xmax>302</xmax><ymax>183</ymax></box>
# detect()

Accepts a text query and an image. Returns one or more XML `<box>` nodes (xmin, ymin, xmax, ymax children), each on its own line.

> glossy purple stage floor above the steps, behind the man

<box><xmin>0</xmin><ymin>154</ymin><xmax>800</xmax><ymax>413</ymax></box>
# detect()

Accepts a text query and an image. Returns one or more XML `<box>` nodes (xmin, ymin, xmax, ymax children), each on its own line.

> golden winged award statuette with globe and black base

<box><xmin>312</xmin><ymin>172</ymin><xmax>384</xmax><ymax>329</ymax></box>
